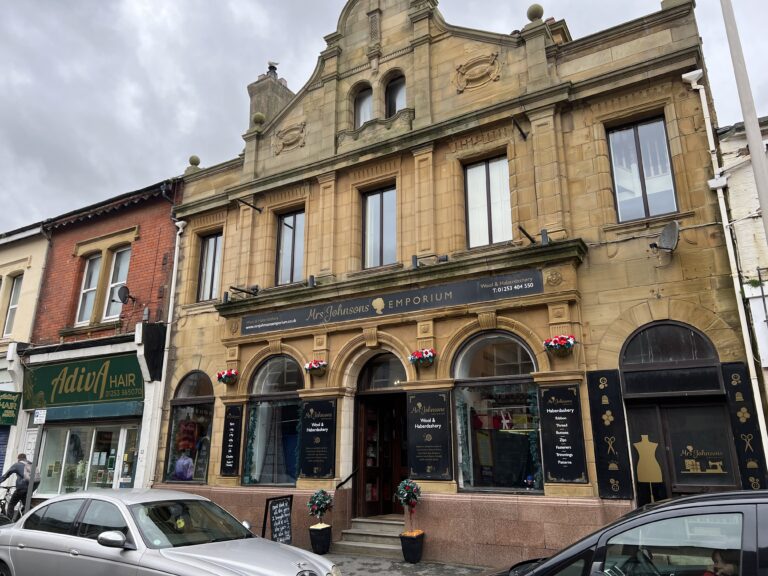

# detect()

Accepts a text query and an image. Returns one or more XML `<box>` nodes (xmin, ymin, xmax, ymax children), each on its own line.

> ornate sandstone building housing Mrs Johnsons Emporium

<box><xmin>157</xmin><ymin>0</ymin><xmax>765</xmax><ymax>565</ymax></box>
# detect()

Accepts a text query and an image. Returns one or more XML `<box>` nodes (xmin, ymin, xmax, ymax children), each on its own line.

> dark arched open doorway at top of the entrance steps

<box><xmin>355</xmin><ymin>352</ymin><xmax>408</xmax><ymax>517</ymax></box>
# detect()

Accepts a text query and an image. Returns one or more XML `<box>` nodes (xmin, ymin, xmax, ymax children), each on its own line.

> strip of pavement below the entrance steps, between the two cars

<box><xmin>325</xmin><ymin>554</ymin><xmax>488</xmax><ymax>576</ymax></box>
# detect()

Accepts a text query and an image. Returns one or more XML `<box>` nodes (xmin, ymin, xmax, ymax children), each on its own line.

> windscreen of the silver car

<box><xmin>128</xmin><ymin>500</ymin><xmax>253</xmax><ymax>548</ymax></box>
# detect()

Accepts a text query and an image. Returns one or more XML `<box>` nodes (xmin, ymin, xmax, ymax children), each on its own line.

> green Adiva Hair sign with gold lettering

<box><xmin>24</xmin><ymin>354</ymin><xmax>144</xmax><ymax>410</ymax></box>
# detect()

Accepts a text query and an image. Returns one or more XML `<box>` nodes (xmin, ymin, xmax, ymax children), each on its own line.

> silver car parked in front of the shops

<box><xmin>0</xmin><ymin>490</ymin><xmax>341</xmax><ymax>576</ymax></box>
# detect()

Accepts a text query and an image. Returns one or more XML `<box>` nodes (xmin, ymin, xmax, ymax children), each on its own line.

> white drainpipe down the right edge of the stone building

<box><xmin>683</xmin><ymin>69</ymin><xmax>768</xmax><ymax>461</ymax></box>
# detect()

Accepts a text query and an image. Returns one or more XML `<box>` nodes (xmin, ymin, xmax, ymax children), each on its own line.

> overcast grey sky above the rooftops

<box><xmin>0</xmin><ymin>0</ymin><xmax>768</xmax><ymax>231</ymax></box>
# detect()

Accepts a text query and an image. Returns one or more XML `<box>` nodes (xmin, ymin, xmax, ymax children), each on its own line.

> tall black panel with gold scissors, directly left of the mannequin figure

<box><xmin>587</xmin><ymin>370</ymin><xmax>634</xmax><ymax>500</ymax></box>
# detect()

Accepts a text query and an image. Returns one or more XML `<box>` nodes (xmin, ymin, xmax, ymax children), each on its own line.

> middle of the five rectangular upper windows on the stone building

<box><xmin>363</xmin><ymin>188</ymin><xmax>397</xmax><ymax>268</ymax></box>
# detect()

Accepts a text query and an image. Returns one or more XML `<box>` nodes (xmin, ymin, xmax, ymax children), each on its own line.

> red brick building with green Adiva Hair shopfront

<box><xmin>19</xmin><ymin>180</ymin><xmax>177</xmax><ymax>498</ymax></box>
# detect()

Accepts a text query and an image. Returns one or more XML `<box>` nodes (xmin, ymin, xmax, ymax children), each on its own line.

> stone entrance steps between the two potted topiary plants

<box><xmin>331</xmin><ymin>514</ymin><xmax>405</xmax><ymax>560</ymax></box>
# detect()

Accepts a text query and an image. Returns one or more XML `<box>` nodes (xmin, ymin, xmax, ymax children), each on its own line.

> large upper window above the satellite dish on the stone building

<box><xmin>608</xmin><ymin>118</ymin><xmax>677</xmax><ymax>222</ymax></box>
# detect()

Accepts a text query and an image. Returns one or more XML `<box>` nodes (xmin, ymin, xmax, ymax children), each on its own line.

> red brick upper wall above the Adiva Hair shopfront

<box><xmin>32</xmin><ymin>197</ymin><xmax>176</xmax><ymax>345</ymax></box>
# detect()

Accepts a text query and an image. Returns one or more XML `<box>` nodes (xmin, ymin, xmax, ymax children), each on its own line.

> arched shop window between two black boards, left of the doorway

<box><xmin>243</xmin><ymin>356</ymin><xmax>304</xmax><ymax>485</ymax></box>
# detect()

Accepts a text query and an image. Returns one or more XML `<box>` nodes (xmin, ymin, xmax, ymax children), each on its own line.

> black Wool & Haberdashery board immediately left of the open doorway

<box><xmin>299</xmin><ymin>400</ymin><xmax>336</xmax><ymax>478</ymax></box>
